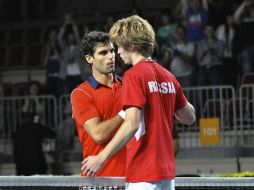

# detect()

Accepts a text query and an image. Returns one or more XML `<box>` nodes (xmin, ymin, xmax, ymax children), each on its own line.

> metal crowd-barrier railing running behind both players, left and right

<box><xmin>0</xmin><ymin>85</ymin><xmax>254</xmax><ymax>159</ymax></box>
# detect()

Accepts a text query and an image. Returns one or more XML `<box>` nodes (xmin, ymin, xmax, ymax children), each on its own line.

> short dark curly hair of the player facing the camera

<box><xmin>80</xmin><ymin>31</ymin><xmax>110</xmax><ymax>60</ymax></box>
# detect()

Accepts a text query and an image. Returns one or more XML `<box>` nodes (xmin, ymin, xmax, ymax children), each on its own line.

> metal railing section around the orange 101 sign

<box><xmin>178</xmin><ymin>86</ymin><xmax>238</xmax><ymax>148</ymax></box>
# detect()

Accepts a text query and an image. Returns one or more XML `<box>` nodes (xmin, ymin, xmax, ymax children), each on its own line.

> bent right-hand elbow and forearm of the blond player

<box><xmin>175</xmin><ymin>102</ymin><xmax>196</xmax><ymax>125</ymax></box>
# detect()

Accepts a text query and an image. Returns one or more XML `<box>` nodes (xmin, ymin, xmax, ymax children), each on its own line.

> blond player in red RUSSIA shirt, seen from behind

<box><xmin>83</xmin><ymin>16</ymin><xmax>195</xmax><ymax>190</ymax></box>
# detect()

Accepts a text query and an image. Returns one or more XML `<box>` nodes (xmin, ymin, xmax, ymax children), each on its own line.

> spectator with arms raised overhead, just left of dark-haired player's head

<box><xmin>58</xmin><ymin>14</ymin><xmax>88</xmax><ymax>93</ymax></box>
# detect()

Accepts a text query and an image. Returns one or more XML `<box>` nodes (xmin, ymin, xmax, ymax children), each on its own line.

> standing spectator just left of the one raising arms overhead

<box><xmin>43</xmin><ymin>30</ymin><xmax>63</xmax><ymax>98</ymax></box>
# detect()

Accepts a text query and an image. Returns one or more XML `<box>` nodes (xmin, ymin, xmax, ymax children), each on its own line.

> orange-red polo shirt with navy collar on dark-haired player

<box><xmin>71</xmin><ymin>76</ymin><xmax>126</xmax><ymax>176</ymax></box>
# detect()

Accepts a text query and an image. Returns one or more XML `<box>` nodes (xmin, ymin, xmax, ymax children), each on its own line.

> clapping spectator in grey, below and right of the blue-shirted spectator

<box><xmin>197</xmin><ymin>25</ymin><xmax>224</xmax><ymax>86</ymax></box>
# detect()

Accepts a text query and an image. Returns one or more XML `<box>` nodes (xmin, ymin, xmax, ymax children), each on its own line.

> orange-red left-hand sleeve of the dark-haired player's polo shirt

<box><xmin>71</xmin><ymin>89</ymin><xmax>100</xmax><ymax>125</ymax></box>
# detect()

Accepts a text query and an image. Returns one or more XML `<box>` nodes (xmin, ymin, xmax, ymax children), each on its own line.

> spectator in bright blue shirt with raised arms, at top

<box><xmin>181</xmin><ymin>0</ymin><xmax>208</xmax><ymax>42</ymax></box>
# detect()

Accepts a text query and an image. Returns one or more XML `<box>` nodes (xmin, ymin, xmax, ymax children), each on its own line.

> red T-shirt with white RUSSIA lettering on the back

<box><xmin>123</xmin><ymin>60</ymin><xmax>187</xmax><ymax>182</ymax></box>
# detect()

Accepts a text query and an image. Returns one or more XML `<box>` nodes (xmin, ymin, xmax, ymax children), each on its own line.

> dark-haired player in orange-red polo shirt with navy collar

<box><xmin>71</xmin><ymin>31</ymin><xmax>126</xmax><ymax>176</ymax></box>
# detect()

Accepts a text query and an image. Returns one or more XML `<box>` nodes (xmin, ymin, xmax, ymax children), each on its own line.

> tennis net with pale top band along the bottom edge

<box><xmin>0</xmin><ymin>176</ymin><xmax>254</xmax><ymax>190</ymax></box>
